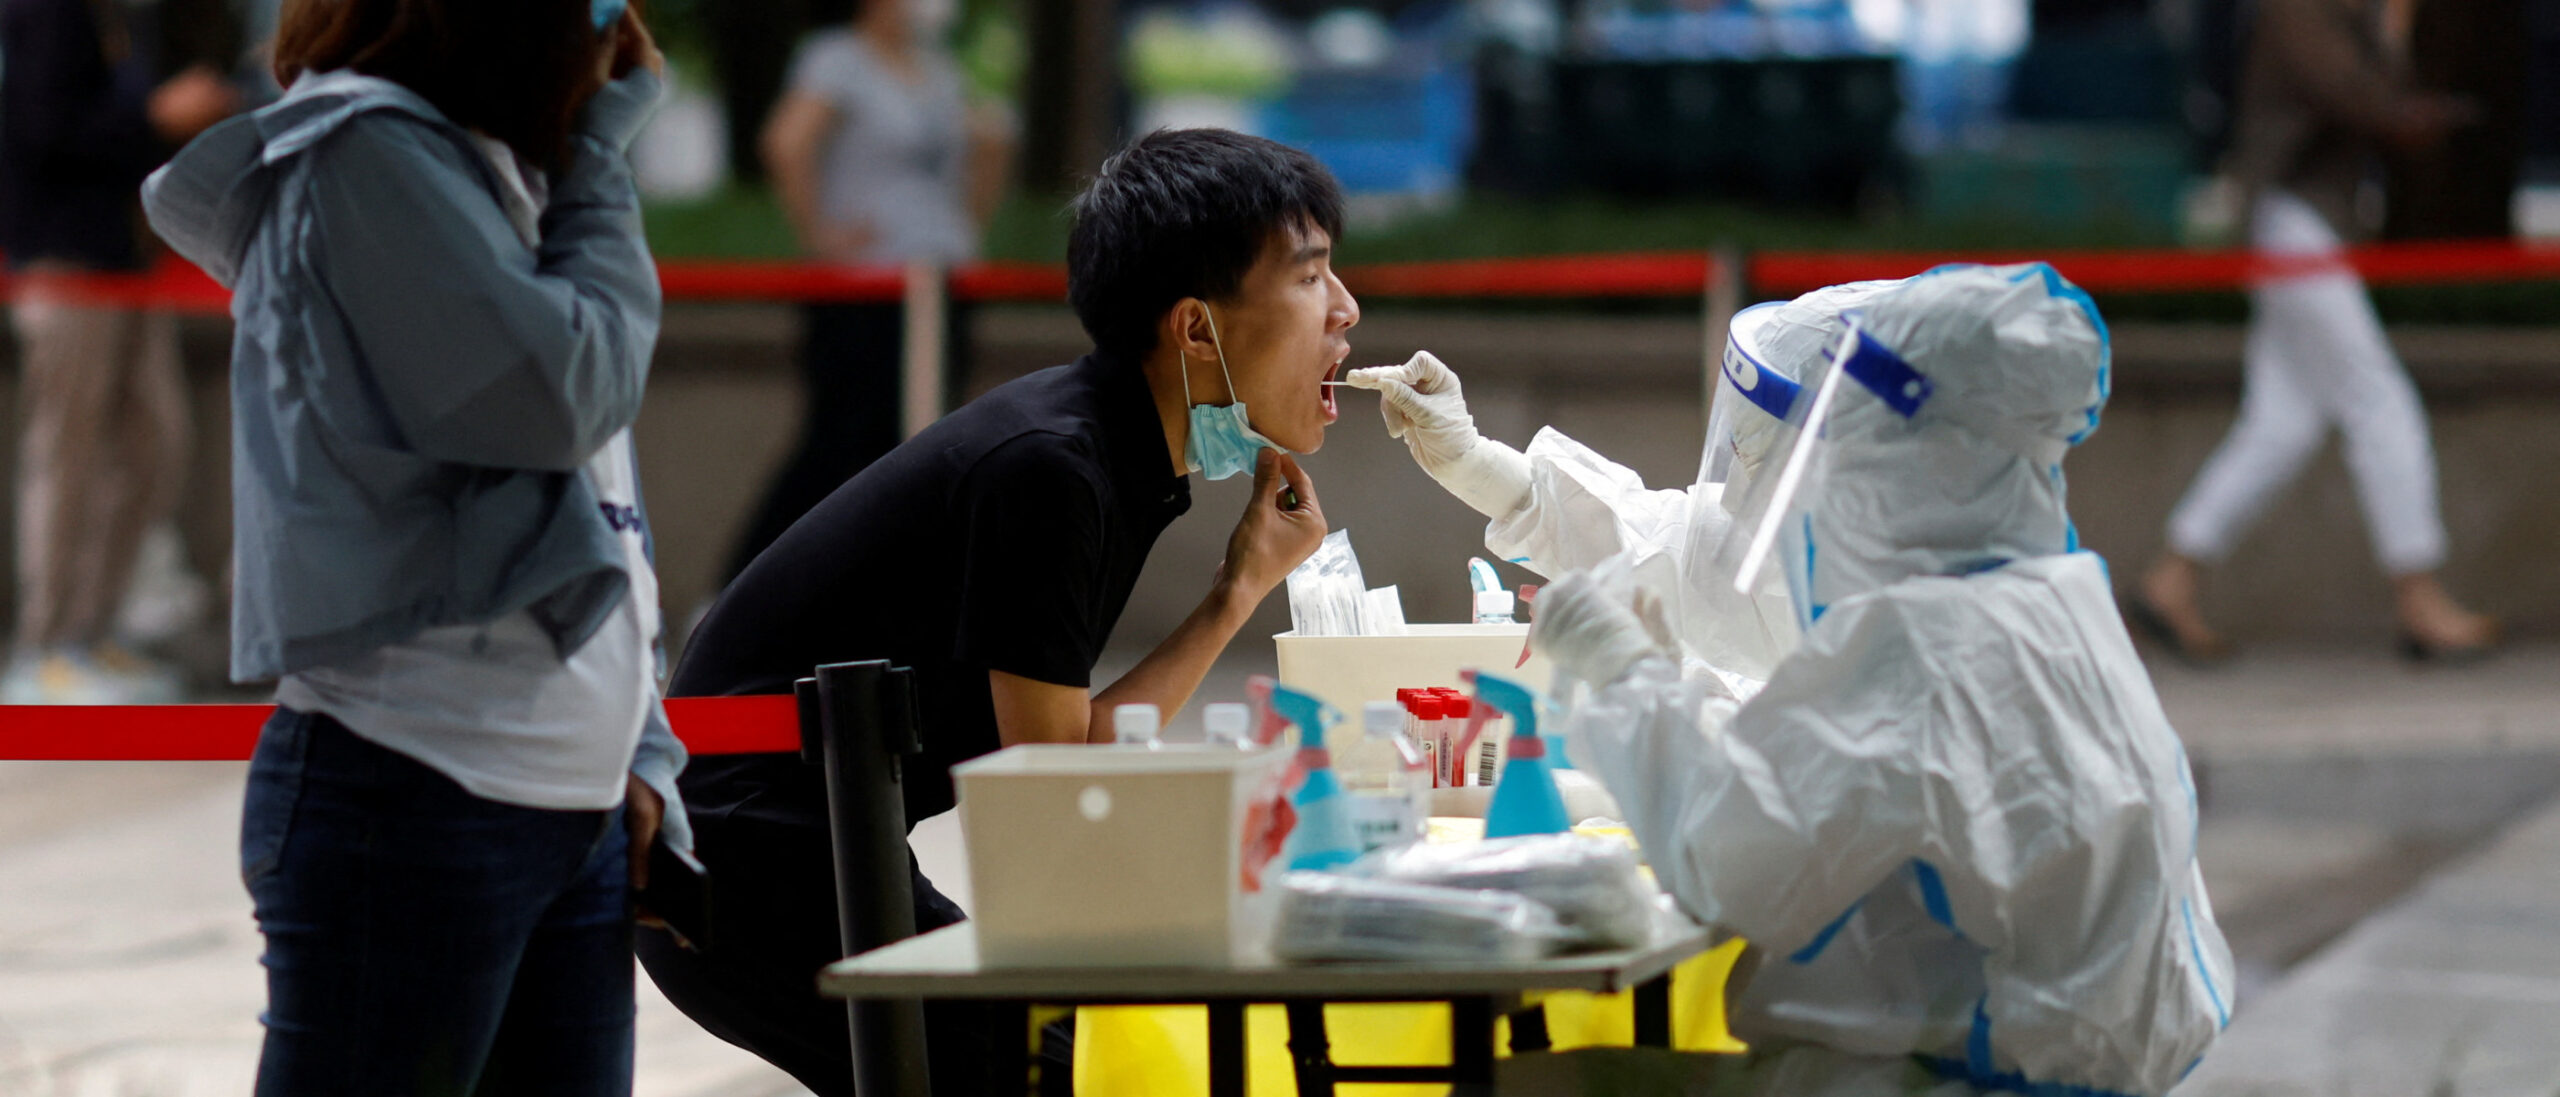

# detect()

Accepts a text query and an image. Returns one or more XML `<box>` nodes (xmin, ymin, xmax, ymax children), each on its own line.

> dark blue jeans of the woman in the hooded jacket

<box><xmin>241</xmin><ymin>708</ymin><xmax>635</xmax><ymax>1097</ymax></box>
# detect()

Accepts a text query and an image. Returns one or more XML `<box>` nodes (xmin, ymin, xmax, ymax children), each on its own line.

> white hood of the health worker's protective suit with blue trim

<box><xmin>1779</xmin><ymin>263</ymin><xmax>2109</xmax><ymax>616</ymax></box>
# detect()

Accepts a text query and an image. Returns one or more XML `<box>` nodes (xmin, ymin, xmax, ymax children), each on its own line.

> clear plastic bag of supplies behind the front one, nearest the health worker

<box><xmin>1349</xmin><ymin>834</ymin><xmax>1659</xmax><ymax>949</ymax></box>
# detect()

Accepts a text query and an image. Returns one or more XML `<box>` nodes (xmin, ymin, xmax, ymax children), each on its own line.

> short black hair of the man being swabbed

<box><xmin>1068</xmin><ymin>130</ymin><xmax>1341</xmax><ymax>358</ymax></box>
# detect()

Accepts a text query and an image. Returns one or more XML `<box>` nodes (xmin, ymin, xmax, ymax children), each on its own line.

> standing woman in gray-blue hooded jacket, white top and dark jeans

<box><xmin>143</xmin><ymin>0</ymin><xmax>686</xmax><ymax>1097</ymax></box>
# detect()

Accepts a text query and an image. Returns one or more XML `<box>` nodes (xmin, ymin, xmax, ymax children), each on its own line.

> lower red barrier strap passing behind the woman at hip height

<box><xmin>0</xmin><ymin>696</ymin><xmax>799</xmax><ymax>762</ymax></box>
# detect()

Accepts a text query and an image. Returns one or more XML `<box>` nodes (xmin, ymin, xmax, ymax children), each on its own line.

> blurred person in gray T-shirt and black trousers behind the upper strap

<box><xmin>722</xmin><ymin>0</ymin><xmax>1011</xmax><ymax>580</ymax></box>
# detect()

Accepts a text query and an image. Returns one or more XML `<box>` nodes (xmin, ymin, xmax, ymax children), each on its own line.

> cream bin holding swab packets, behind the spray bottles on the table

<box><xmin>1272</xmin><ymin>624</ymin><xmax>1556</xmax><ymax>734</ymax></box>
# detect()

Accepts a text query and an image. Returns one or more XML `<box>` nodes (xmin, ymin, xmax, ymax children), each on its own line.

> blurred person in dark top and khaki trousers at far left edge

<box><xmin>0</xmin><ymin>0</ymin><xmax>241</xmax><ymax>703</ymax></box>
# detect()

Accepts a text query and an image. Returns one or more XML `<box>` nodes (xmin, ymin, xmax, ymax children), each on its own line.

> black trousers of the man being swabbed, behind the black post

<box><xmin>637</xmin><ymin>816</ymin><xmax>993</xmax><ymax>1097</ymax></box>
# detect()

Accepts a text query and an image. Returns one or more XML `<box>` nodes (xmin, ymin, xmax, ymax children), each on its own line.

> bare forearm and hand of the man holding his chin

<box><xmin>988</xmin><ymin>450</ymin><xmax>1326</xmax><ymax>747</ymax></box>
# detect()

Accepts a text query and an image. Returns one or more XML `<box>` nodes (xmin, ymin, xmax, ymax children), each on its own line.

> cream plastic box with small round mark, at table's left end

<box><xmin>952</xmin><ymin>744</ymin><xmax>1288</xmax><ymax>967</ymax></box>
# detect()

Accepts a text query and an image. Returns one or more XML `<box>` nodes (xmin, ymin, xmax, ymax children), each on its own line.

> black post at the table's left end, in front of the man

<box><xmin>801</xmin><ymin>660</ymin><xmax>932</xmax><ymax>1097</ymax></box>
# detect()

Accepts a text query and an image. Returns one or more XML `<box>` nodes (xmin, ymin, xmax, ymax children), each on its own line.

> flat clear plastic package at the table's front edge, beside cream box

<box><xmin>1272</xmin><ymin>872</ymin><xmax>1574</xmax><ymax>964</ymax></box>
